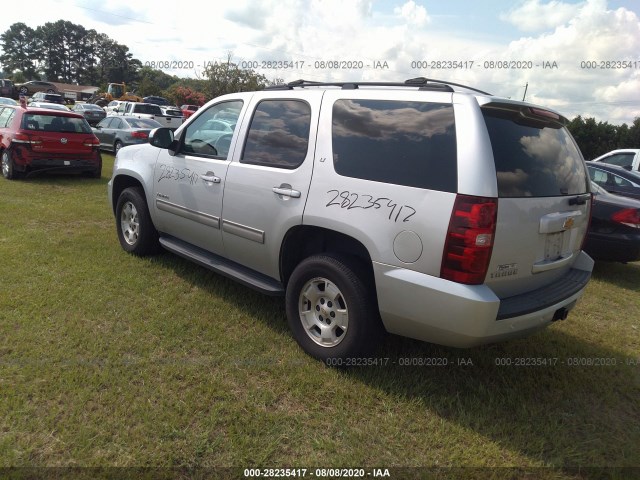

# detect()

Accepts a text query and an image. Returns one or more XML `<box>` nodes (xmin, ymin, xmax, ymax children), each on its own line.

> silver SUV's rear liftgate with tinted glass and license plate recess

<box><xmin>482</xmin><ymin>104</ymin><xmax>591</xmax><ymax>296</ymax></box>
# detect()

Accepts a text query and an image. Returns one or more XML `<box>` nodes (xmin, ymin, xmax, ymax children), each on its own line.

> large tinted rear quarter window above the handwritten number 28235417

<box><xmin>332</xmin><ymin>100</ymin><xmax>458</xmax><ymax>192</ymax></box>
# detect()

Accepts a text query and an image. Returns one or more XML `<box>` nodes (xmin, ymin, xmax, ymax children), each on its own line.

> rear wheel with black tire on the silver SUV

<box><xmin>286</xmin><ymin>254</ymin><xmax>384</xmax><ymax>360</ymax></box>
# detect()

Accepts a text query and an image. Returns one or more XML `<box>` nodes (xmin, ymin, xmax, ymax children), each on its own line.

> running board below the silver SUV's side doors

<box><xmin>160</xmin><ymin>236</ymin><xmax>284</xmax><ymax>296</ymax></box>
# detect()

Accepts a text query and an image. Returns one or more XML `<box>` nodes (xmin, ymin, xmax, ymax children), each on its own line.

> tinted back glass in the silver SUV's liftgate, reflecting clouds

<box><xmin>482</xmin><ymin>108</ymin><xmax>588</xmax><ymax>197</ymax></box>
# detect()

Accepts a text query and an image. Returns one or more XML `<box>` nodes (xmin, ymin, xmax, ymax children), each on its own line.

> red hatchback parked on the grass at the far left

<box><xmin>0</xmin><ymin>105</ymin><xmax>102</xmax><ymax>180</ymax></box>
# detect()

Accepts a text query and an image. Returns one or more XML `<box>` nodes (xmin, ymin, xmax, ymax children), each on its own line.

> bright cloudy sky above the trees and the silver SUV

<box><xmin>0</xmin><ymin>0</ymin><xmax>640</xmax><ymax>124</ymax></box>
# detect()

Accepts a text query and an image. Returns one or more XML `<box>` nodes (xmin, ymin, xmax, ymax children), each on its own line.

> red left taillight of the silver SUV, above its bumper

<box><xmin>440</xmin><ymin>195</ymin><xmax>498</xmax><ymax>285</ymax></box>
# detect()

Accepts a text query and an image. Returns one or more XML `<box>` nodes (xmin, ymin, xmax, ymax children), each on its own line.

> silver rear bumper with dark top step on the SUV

<box><xmin>373</xmin><ymin>252</ymin><xmax>593</xmax><ymax>348</ymax></box>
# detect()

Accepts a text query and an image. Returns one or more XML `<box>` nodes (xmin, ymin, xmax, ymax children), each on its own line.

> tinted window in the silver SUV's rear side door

<box><xmin>240</xmin><ymin>100</ymin><xmax>311</xmax><ymax>169</ymax></box>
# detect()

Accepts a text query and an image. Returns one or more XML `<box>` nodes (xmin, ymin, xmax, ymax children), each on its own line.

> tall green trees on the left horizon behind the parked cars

<box><xmin>0</xmin><ymin>20</ymin><xmax>273</xmax><ymax>105</ymax></box>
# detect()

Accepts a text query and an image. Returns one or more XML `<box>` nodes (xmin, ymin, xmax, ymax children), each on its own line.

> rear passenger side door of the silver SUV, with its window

<box><xmin>220</xmin><ymin>90</ymin><xmax>324</xmax><ymax>278</ymax></box>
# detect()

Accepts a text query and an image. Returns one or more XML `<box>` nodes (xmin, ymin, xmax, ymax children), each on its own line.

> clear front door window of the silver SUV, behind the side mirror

<box><xmin>182</xmin><ymin>100</ymin><xmax>243</xmax><ymax>159</ymax></box>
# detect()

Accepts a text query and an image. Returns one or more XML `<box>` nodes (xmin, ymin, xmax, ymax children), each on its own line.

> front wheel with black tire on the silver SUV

<box><xmin>116</xmin><ymin>187</ymin><xmax>160</xmax><ymax>257</ymax></box>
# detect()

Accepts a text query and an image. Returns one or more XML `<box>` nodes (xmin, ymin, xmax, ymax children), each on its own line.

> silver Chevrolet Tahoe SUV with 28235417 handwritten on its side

<box><xmin>108</xmin><ymin>78</ymin><xmax>593</xmax><ymax>360</ymax></box>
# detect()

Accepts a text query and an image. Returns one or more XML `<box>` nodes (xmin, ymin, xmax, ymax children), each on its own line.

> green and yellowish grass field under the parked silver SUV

<box><xmin>0</xmin><ymin>155</ymin><xmax>640</xmax><ymax>478</ymax></box>
